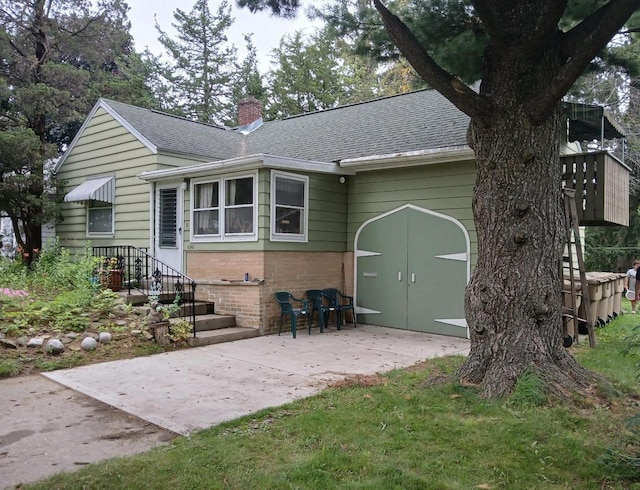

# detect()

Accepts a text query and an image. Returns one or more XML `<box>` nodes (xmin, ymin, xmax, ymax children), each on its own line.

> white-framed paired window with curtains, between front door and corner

<box><xmin>191</xmin><ymin>175</ymin><xmax>257</xmax><ymax>241</ymax></box>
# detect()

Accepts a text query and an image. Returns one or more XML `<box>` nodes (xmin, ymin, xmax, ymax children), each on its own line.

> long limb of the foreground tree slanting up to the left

<box><xmin>373</xmin><ymin>0</ymin><xmax>491</xmax><ymax>119</ymax></box>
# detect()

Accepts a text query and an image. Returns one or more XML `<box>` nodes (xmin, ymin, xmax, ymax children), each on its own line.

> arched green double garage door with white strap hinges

<box><xmin>355</xmin><ymin>205</ymin><xmax>470</xmax><ymax>338</ymax></box>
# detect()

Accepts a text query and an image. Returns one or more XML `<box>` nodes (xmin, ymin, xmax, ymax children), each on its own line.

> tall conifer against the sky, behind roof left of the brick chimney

<box><xmin>156</xmin><ymin>0</ymin><xmax>239</xmax><ymax>124</ymax></box>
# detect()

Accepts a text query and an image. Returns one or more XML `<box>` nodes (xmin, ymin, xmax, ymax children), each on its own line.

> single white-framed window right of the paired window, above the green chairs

<box><xmin>271</xmin><ymin>171</ymin><xmax>309</xmax><ymax>242</ymax></box>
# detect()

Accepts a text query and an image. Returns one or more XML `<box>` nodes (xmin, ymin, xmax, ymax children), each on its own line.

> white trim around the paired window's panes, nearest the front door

<box><xmin>189</xmin><ymin>172</ymin><xmax>258</xmax><ymax>243</ymax></box>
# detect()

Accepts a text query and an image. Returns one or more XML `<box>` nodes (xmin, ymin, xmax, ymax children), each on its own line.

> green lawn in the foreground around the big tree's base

<box><xmin>24</xmin><ymin>315</ymin><xmax>640</xmax><ymax>490</ymax></box>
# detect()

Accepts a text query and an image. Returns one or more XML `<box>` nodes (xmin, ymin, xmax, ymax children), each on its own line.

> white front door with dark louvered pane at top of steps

<box><xmin>154</xmin><ymin>183</ymin><xmax>182</xmax><ymax>272</ymax></box>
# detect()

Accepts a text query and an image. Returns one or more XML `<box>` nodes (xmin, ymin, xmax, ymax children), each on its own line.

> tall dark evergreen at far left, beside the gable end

<box><xmin>0</xmin><ymin>0</ymin><xmax>151</xmax><ymax>262</ymax></box>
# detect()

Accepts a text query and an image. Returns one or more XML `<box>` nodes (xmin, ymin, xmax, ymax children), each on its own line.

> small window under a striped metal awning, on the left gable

<box><xmin>64</xmin><ymin>176</ymin><xmax>115</xmax><ymax>236</ymax></box>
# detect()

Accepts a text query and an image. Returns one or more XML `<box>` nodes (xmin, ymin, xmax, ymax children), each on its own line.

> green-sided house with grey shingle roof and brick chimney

<box><xmin>57</xmin><ymin>90</ymin><xmax>628</xmax><ymax>337</ymax></box>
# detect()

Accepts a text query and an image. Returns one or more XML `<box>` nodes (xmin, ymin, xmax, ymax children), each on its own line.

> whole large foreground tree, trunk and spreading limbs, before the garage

<box><xmin>240</xmin><ymin>0</ymin><xmax>640</xmax><ymax>397</ymax></box>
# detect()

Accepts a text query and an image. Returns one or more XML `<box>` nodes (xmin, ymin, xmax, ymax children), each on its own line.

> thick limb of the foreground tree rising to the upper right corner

<box><xmin>530</xmin><ymin>0</ymin><xmax>640</xmax><ymax>120</ymax></box>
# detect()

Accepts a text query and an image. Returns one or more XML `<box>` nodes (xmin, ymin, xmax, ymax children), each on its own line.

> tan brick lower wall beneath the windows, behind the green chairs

<box><xmin>187</xmin><ymin>252</ymin><xmax>353</xmax><ymax>334</ymax></box>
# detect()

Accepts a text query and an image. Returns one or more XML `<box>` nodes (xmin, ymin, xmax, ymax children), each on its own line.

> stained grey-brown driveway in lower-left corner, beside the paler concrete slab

<box><xmin>0</xmin><ymin>375</ymin><xmax>176</xmax><ymax>489</ymax></box>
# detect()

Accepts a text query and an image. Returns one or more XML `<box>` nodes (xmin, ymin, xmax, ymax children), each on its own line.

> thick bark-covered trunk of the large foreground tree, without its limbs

<box><xmin>458</xmin><ymin>47</ymin><xmax>595</xmax><ymax>397</ymax></box>
